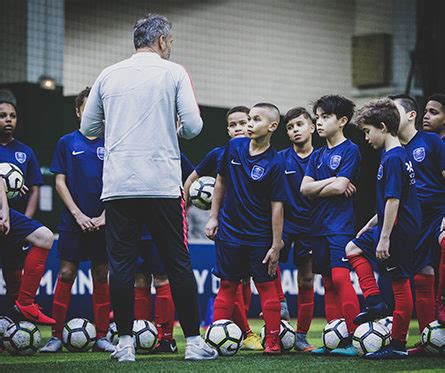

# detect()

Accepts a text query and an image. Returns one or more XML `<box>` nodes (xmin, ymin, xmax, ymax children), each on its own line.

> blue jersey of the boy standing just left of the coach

<box><xmin>51</xmin><ymin>130</ymin><xmax>105</xmax><ymax>232</ymax></box>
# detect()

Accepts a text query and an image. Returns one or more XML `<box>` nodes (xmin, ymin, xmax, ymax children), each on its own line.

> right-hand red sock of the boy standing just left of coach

<box><xmin>92</xmin><ymin>279</ymin><xmax>110</xmax><ymax>339</ymax></box>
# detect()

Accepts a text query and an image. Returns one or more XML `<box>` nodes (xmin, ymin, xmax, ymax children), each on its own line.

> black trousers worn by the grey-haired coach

<box><xmin>105</xmin><ymin>198</ymin><xmax>199</xmax><ymax>337</ymax></box>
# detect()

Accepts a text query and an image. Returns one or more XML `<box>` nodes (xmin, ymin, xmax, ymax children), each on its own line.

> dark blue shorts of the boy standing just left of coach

<box><xmin>57</xmin><ymin>229</ymin><xmax>108</xmax><ymax>263</ymax></box>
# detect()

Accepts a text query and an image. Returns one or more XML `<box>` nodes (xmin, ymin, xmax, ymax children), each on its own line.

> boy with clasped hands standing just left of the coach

<box><xmin>40</xmin><ymin>87</ymin><xmax>114</xmax><ymax>353</ymax></box>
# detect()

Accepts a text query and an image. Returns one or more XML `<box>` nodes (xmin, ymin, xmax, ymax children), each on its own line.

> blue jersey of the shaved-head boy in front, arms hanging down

<box><xmin>217</xmin><ymin>138</ymin><xmax>286</xmax><ymax>247</ymax></box>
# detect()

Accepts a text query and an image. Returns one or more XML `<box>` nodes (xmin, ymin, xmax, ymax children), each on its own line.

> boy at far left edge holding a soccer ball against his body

<box><xmin>0</xmin><ymin>90</ymin><xmax>43</xmax><ymax>302</ymax></box>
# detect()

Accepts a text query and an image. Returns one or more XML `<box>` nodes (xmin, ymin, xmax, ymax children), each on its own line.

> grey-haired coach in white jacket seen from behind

<box><xmin>80</xmin><ymin>14</ymin><xmax>217</xmax><ymax>362</ymax></box>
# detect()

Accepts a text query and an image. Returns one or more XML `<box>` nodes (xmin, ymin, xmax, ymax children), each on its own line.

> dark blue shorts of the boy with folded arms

<box><xmin>311</xmin><ymin>234</ymin><xmax>352</xmax><ymax>275</ymax></box>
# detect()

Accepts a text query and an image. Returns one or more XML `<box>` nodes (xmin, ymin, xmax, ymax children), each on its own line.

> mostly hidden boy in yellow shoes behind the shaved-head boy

<box><xmin>184</xmin><ymin>106</ymin><xmax>264</xmax><ymax>350</ymax></box>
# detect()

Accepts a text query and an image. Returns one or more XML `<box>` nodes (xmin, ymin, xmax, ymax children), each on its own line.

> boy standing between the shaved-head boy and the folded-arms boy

<box><xmin>278</xmin><ymin>107</ymin><xmax>315</xmax><ymax>352</ymax></box>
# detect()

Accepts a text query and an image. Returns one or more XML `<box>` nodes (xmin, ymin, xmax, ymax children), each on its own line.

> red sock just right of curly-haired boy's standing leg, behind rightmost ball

<box><xmin>414</xmin><ymin>273</ymin><xmax>435</xmax><ymax>333</ymax></box>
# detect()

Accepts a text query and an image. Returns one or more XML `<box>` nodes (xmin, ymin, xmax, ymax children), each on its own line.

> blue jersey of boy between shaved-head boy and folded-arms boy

<box><xmin>278</xmin><ymin>146</ymin><xmax>311</xmax><ymax>235</ymax></box>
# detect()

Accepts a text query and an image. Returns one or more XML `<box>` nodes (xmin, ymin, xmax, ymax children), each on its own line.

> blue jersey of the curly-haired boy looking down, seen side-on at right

<box><xmin>377</xmin><ymin>146</ymin><xmax>422</xmax><ymax>235</ymax></box>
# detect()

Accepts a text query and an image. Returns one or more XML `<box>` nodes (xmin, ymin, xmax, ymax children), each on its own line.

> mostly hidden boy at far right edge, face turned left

<box><xmin>423</xmin><ymin>93</ymin><xmax>445</xmax><ymax>324</ymax></box>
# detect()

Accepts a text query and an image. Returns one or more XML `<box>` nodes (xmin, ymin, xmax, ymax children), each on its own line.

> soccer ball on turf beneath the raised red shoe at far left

<box><xmin>3</xmin><ymin>321</ymin><xmax>41</xmax><ymax>355</ymax></box>
